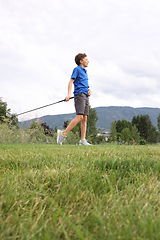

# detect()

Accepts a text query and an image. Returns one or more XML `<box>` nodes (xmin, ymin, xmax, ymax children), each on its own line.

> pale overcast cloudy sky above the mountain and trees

<box><xmin>0</xmin><ymin>0</ymin><xmax>160</xmax><ymax>121</ymax></box>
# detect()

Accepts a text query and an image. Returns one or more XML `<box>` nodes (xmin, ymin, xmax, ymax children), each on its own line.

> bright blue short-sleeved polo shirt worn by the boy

<box><xmin>71</xmin><ymin>66</ymin><xmax>89</xmax><ymax>95</ymax></box>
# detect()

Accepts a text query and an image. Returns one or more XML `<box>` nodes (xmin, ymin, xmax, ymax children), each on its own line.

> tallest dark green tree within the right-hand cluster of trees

<box><xmin>132</xmin><ymin>114</ymin><xmax>152</xmax><ymax>140</ymax></box>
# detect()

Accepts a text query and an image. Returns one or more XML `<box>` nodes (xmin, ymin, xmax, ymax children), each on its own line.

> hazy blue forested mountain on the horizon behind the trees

<box><xmin>20</xmin><ymin>107</ymin><xmax>160</xmax><ymax>131</ymax></box>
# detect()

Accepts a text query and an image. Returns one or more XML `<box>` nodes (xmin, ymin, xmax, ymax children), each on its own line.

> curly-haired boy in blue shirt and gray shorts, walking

<box><xmin>57</xmin><ymin>53</ymin><xmax>92</xmax><ymax>145</ymax></box>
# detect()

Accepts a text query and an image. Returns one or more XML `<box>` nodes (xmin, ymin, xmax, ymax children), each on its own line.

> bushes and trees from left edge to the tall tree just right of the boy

<box><xmin>0</xmin><ymin>98</ymin><xmax>102</xmax><ymax>144</ymax></box>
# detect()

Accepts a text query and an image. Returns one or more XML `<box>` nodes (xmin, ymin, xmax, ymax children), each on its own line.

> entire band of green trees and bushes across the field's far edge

<box><xmin>0</xmin><ymin>98</ymin><xmax>160</xmax><ymax>144</ymax></box>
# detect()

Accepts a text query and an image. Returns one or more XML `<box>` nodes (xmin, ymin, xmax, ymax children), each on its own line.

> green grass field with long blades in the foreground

<box><xmin>0</xmin><ymin>144</ymin><xmax>160</xmax><ymax>240</ymax></box>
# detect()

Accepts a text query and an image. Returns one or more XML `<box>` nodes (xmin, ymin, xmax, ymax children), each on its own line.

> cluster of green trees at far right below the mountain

<box><xmin>109</xmin><ymin>114</ymin><xmax>160</xmax><ymax>144</ymax></box>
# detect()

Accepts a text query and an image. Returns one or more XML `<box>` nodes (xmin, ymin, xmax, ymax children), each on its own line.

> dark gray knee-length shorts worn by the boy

<box><xmin>74</xmin><ymin>93</ymin><xmax>89</xmax><ymax>116</ymax></box>
